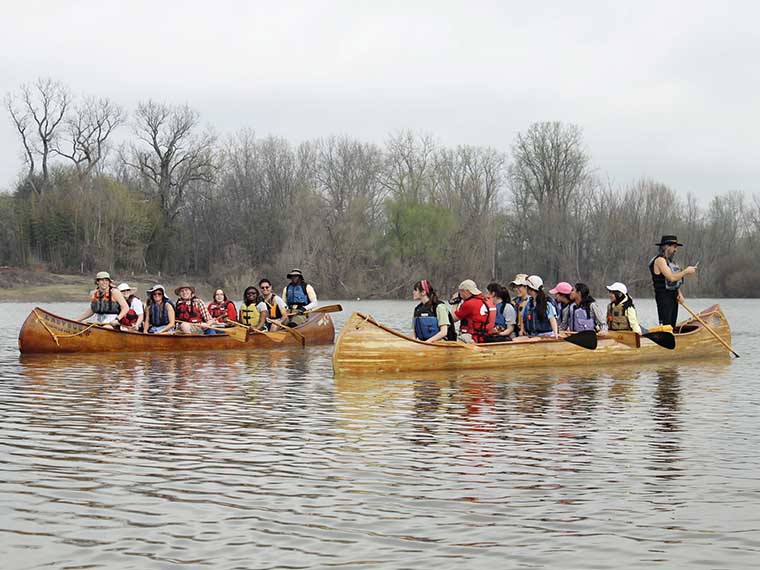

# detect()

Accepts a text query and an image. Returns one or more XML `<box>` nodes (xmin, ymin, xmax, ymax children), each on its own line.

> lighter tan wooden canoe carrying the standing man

<box><xmin>333</xmin><ymin>305</ymin><xmax>731</xmax><ymax>375</ymax></box>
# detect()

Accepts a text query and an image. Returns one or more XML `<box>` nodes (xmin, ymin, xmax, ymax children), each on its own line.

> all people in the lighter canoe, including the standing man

<box><xmin>412</xmin><ymin>235</ymin><xmax>697</xmax><ymax>343</ymax></box>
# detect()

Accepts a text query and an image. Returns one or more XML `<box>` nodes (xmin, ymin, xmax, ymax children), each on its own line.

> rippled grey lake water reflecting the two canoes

<box><xmin>0</xmin><ymin>300</ymin><xmax>760</xmax><ymax>569</ymax></box>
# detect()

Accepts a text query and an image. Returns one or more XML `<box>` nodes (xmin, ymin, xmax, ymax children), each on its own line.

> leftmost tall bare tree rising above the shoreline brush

<box><xmin>5</xmin><ymin>79</ymin><xmax>71</xmax><ymax>192</ymax></box>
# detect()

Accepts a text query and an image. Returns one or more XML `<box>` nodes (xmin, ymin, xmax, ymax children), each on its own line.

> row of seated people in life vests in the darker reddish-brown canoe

<box><xmin>79</xmin><ymin>268</ymin><xmax>318</xmax><ymax>334</ymax></box>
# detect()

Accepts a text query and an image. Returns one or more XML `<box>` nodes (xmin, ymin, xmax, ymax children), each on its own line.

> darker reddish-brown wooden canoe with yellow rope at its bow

<box><xmin>18</xmin><ymin>307</ymin><xmax>335</xmax><ymax>354</ymax></box>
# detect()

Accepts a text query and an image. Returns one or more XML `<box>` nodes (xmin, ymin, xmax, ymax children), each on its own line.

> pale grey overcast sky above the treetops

<box><xmin>0</xmin><ymin>0</ymin><xmax>760</xmax><ymax>201</ymax></box>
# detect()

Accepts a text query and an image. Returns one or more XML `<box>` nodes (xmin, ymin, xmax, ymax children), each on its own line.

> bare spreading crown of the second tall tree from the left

<box><xmin>55</xmin><ymin>98</ymin><xmax>124</xmax><ymax>178</ymax></box>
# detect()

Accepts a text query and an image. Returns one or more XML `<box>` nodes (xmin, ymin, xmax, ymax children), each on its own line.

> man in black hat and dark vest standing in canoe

<box><xmin>649</xmin><ymin>235</ymin><xmax>697</xmax><ymax>327</ymax></box>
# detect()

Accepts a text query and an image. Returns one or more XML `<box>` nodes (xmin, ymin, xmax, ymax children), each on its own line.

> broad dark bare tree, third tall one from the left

<box><xmin>124</xmin><ymin>101</ymin><xmax>217</xmax><ymax>224</ymax></box>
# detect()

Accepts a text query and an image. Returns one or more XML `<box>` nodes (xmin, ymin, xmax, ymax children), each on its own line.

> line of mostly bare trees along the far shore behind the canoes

<box><xmin>0</xmin><ymin>79</ymin><xmax>760</xmax><ymax>298</ymax></box>
